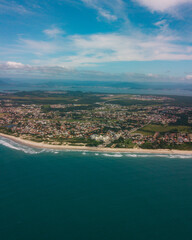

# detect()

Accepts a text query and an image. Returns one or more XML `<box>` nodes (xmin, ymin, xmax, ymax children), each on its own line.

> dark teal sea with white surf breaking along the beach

<box><xmin>0</xmin><ymin>138</ymin><xmax>192</xmax><ymax>240</ymax></box>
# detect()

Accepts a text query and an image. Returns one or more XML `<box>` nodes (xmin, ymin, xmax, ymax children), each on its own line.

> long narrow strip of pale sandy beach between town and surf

<box><xmin>0</xmin><ymin>133</ymin><xmax>192</xmax><ymax>155</ymax></box>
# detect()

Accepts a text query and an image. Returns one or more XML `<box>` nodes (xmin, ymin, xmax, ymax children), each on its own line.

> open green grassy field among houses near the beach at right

<box><xmin>135</xmin><ymin>124</ymin><xmax>192</xmax><ymax>135</ymax></box>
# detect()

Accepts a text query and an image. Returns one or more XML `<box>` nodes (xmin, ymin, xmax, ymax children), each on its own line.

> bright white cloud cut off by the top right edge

<box><xmin>132</xmin><ymin>0</ymin><xmax>192</xmax><ymax>12</ymax></box>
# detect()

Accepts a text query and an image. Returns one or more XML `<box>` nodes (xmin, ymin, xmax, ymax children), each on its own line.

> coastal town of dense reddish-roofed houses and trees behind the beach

<box><xmin>0</xmin><ymin>92</ymin><xmax>192</xmax><ymax>150</ymax></box>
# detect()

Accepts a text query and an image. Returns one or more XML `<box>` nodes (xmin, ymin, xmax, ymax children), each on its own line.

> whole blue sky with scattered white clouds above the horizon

<box><xmin>0</xmin><ymin>0</ymin><xmax>192</xmax><ymax>83</ymax></box>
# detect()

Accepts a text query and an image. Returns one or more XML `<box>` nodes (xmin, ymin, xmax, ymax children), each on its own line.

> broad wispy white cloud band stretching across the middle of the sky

<box><xmin>0</xmin><ymin>27</ymin><xmax>192</xmax><ymax>68</ymax></box>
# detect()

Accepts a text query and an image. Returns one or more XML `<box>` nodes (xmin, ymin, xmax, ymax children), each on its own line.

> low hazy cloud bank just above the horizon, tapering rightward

<box><xmin>0</xmin><ymin>62</ymin><xmax>180</xmax><ymax>82</ymax></box>
